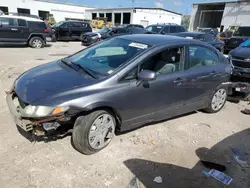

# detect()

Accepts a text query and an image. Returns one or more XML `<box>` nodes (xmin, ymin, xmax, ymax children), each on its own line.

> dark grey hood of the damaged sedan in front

<box><xmin>14</xmin><ymin>61</ymin><xmax>96</xmax><ymax>104</ymax></box>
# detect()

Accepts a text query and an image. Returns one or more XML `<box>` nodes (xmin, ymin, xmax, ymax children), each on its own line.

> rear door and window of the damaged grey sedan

<box><xmin>186</xmin><ymin>45</ymin><xmax>227</xmax><ymax>107</ymax></box>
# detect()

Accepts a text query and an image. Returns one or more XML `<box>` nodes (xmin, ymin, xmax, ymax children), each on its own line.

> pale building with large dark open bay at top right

<box><xmin>189</xmin><ymin>0</ymin><xmax>250</xmax><ymax>31</ymax></box>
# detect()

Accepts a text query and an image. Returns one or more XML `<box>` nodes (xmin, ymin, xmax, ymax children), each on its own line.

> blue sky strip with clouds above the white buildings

<box><xmin>56</xmin><ymin>0</ymin><xmax>235</xmax><ymax>14</ymax></box>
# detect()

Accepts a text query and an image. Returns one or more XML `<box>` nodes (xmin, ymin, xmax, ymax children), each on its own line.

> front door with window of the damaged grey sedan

<box><xmin>118</xmin><ymin>46</ymin><xmax>188</xmax><ymax>128</ymax></box>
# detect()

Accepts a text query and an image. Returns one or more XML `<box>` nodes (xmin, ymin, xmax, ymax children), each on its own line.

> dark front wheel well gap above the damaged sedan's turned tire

<box><xmin>74</xmin><ymin>106</ymin><xmax>122</xmax><ymax>130</ymax></box>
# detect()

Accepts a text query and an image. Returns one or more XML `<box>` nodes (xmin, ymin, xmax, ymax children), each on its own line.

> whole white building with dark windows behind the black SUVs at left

<box><xmin>0</xmin><ymin>0</ymin><xmax>91</xmax><ymax>22</ymax></box>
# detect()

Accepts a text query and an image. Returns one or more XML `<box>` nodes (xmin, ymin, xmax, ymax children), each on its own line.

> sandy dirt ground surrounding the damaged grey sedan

<box><xmin>0</xmin><ymin>42</ymin><xmax>250</xmax><ymax>188</ymax></box>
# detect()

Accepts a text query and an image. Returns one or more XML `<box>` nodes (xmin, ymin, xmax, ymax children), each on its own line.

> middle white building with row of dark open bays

<box><xmin>86</xmin><ymin>8</ymin><xmax>182</xmax><ymax>27</ymax></box>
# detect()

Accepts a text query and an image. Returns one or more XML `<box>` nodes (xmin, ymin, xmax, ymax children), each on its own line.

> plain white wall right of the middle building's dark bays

<box><xmin>132</xmin><ymin>9</ymin><xmax>181</xmax><ymax>27</ymax></box>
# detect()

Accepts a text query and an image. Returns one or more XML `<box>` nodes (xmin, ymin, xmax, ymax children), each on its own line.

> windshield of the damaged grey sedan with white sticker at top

<box><xmin>69</xmin><ymin>38</ymin><xmax>149</xmax><ymax>76</ymax></box>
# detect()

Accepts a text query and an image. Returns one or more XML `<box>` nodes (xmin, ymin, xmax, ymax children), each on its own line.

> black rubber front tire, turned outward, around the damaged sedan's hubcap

<box><xmin>72</xmin><ymin>110</ymin><xmax>116</xmax><ymax>155</ymax></box>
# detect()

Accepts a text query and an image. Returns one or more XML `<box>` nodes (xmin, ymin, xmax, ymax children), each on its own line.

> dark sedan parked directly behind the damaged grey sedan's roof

<box><xmin>81</xmin><ymin>25</ymin><xmax>152</xmax><ymax>46</ymax></box>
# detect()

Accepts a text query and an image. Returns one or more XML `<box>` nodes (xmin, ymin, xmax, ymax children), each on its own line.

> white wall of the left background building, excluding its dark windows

<box><xmin>0</xmin><ymin>0</ymin><xmax>91</xmax><ymax>22</ymax></box>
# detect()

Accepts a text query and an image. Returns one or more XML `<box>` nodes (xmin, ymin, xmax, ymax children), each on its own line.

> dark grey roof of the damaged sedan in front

<box><xmin>117</xmin><ymin>34</ymin><xmax>203</xmax><ymax>46</ymax></box>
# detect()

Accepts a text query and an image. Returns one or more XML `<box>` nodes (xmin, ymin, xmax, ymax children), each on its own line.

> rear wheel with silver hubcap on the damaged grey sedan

<box><xmin>204</xmin><ymin>86</ymin><xmax>228</xmax><ymax>113</ymax></box>
